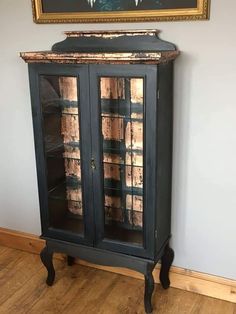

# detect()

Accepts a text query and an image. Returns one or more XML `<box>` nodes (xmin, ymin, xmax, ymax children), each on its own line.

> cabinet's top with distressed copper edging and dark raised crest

<box><xmin>20</xmin><ymin>30</ymin><xmax>179</xmax><ymax>64</ymax></box>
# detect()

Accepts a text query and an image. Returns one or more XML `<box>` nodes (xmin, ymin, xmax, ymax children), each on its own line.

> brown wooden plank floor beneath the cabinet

<box><xmin>0</xmin><ymin>246</ymin><xmax>236</xmax><ymax>314</ymax></box>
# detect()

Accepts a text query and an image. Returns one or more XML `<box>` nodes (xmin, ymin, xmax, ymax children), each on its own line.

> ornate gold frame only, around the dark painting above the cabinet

<box><xmin>32</xmin><ymin>0</ymin><xmax>210</xmax><ymax>24</ymax></box>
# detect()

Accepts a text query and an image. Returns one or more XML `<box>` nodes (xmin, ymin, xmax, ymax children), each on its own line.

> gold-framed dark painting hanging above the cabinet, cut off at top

<box><xmin>32</xmin><ymin>0</ymin><xmax>210</xmax><ymax>23</ymax></box>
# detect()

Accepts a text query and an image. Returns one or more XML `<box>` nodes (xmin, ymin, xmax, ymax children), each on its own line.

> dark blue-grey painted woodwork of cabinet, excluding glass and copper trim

<box><xmin>25</xmin><ymin>31</ymin><xmax>176</xmax><ymax>313</ymax></box>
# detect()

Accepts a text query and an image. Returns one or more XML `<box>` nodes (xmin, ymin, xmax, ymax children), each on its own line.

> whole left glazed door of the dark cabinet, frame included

<box><xmin>29</xmin><ymin>64</ymin><xmax>93</xmax><ymax>245</ymax></box>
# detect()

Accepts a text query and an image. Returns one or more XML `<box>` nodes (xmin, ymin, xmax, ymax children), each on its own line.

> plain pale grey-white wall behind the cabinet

<box><xmin>0</xmin><ymin>0</ymin><xmax>236</xmax><ymax>279</ymax></box>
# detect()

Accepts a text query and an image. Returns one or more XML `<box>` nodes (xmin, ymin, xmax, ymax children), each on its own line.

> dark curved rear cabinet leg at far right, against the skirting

<box><xmin>160</xmin><ymin>243</ymin><xmax>174</xmax><ymax>289</ymax></box>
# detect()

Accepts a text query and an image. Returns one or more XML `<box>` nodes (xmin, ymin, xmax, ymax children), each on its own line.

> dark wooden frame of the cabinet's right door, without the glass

<box><xmin>89</xmin><ymin>64</ymin><xmax>158</xmax><ymax>258</ymax></box>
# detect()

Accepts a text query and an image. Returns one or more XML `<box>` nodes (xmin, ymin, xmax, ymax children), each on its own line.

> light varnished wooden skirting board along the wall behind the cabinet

<box><xmin>0</xmin><ymin>228</ymin><xmax>236</xmax><ymax>303</ymax></box>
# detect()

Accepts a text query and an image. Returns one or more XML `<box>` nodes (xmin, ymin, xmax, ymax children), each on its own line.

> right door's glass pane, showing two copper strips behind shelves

<box><xmin>100</xmin><ymin>77</ymin><xmax>144</xmax><ymax>246</ymax></box>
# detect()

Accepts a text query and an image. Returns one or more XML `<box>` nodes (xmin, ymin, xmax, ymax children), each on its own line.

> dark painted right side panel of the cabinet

<box><xmin>156</xmin><ymin>62</ymin><xmax>173</xmax><ymax>257</ymax></box>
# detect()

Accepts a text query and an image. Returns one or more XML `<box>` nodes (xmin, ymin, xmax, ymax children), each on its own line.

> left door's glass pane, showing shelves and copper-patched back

<box><xmin>40</xmin><ymin>75</ymin><xmax>84</xmax><ymax>233</ymax></box>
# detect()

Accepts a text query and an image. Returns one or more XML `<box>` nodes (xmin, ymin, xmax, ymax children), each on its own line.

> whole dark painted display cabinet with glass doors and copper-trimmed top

<box><xmin>21</xmin><ymin>31</ymin><xmax>178</xmax><ymax>312</ymax></box>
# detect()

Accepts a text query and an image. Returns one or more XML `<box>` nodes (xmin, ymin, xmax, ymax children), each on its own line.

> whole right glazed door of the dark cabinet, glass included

<box><xmin>90</xmin><ymin>65</ymin><xmax>157</xmax><ymax>256</ymax></box>
